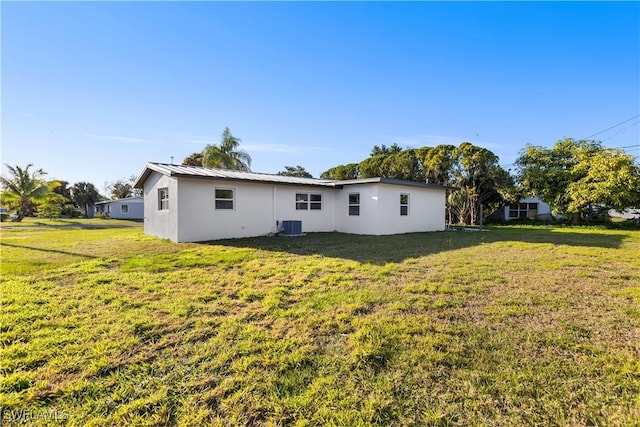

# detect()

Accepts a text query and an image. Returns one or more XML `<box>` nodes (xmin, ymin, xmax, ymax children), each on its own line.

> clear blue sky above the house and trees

<box><xmin>0</xmin><ymin>2</ymin><xmax>640</xmax><ymax>190</ymax></box>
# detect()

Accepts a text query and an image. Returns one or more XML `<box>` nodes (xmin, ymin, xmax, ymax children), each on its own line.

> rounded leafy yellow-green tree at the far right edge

<box><xmin>516</xmin><ymin>138</ymin><xmax>640</xmax><ymax>222</ymax></box>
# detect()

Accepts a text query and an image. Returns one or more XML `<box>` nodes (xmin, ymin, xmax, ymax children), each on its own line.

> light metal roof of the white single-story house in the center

<box><xmin>133</xmin><ymin>163</ymin><xmax>447</xmax><ymax>189</ymax></box>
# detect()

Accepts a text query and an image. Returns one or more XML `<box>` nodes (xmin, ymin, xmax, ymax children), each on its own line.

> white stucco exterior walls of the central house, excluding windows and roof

<box><xmin>144</xmin><ymin>172</ymin><xmax>445</xmax><ymax>242</ymax></box>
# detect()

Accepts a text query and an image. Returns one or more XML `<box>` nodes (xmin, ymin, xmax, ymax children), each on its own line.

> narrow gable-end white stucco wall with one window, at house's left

<box><xmin>144</xmin><ymin>172</ymin><xmax>179</xmax><ymax>242</ymax></box>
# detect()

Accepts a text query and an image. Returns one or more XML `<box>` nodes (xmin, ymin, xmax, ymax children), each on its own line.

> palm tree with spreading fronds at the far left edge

<box><xmin>0</xmin><ymin>163</ymin><xmax>49</xmax><ymax>222</ymax></box>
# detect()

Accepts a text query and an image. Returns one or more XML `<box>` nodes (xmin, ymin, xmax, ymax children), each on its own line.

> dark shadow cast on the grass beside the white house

<box><xmin>208</xmin><ymin>227</ymin><xmax>626</xmax><ymax>265</ymax></box>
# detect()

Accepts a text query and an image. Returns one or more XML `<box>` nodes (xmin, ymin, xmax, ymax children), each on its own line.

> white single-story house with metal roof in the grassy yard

<box><xmin>134</xmin><ymin>163</ymin><xmax>447</xmax><ymax>242</ymax></box>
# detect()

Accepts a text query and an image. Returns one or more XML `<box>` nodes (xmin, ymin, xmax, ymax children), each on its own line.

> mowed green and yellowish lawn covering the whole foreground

<box><xmin>0</xmin><ymin>221</ymin><xmax>640</xmax><ymax>426</ymax></box>
